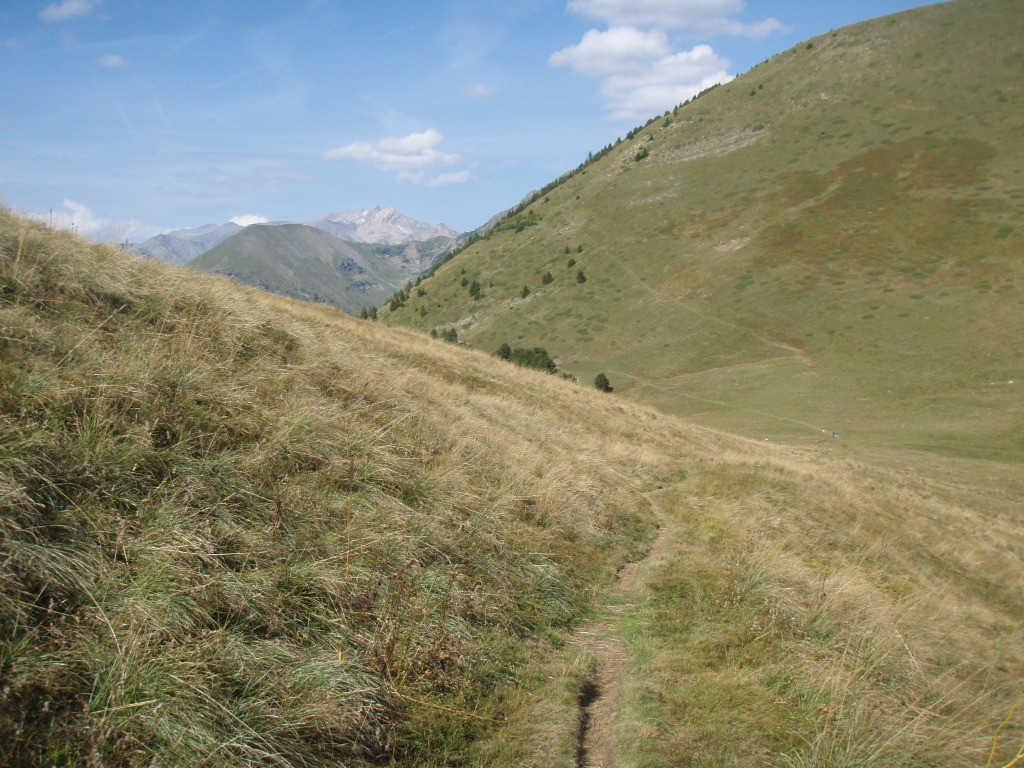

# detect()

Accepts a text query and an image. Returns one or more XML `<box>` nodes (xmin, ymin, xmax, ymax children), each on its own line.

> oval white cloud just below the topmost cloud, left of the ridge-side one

<box><xmin>548</xmin><ymin>27</ymin><xmax>672</xmax><ymax>75</ymax></box>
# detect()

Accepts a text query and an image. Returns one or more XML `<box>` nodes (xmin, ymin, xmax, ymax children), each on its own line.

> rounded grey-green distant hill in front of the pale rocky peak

<box><xmin>188</xmin><ymin>224</ymin><xmax>449</xmax><ymax>314</ymax></box>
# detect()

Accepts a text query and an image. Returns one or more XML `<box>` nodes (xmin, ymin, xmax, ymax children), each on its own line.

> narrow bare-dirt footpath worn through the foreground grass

<box><xmin>575</xmin><ymin>499</ymin><xmax>668</xmax><ymax>768</ymax></box>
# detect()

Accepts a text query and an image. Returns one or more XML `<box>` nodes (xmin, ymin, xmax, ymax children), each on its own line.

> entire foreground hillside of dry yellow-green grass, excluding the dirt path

<box><xmin>0</xmin><ymin>212</ymin><xmax>1024</xmax><ymax>768</ymax></box>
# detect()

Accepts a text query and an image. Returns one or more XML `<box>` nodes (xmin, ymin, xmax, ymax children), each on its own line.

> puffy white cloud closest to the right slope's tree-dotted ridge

<box><xmin>601</xmin><ymin>45</ymin><xmax>732</xmax><ymax>121</ymax></box>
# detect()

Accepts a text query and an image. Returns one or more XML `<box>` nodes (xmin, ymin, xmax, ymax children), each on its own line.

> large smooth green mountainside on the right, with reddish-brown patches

<box><xmin>385</xmin><ymin>0</ymin><xmax>1024</xmax><ymax>460</ymax></box>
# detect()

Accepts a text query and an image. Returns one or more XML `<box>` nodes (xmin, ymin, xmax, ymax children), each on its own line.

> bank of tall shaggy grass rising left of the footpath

<box><xmin>0</xmin><ymin>207</ymin><xmax>674</xmax><ymax>765</ymax></box>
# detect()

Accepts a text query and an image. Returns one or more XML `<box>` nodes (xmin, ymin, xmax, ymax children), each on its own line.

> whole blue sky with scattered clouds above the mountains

<box><xmin>0</xmin><ymin>0</ymin><xmax>926</xmax><ymax>242</ymax></box>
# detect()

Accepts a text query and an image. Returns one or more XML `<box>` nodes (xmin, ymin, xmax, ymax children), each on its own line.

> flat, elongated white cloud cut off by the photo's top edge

<box><xmin>568</xmin><ymin>0</ymin><xmax>784</xmax><ymax>37</ymax></box>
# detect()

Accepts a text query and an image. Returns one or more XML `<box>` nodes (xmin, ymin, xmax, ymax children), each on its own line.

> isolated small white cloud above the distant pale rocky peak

<box><xmin>324</xmin><ymin>128</ymin><xmax>472</xmax><ymax>186</ymax></box>
